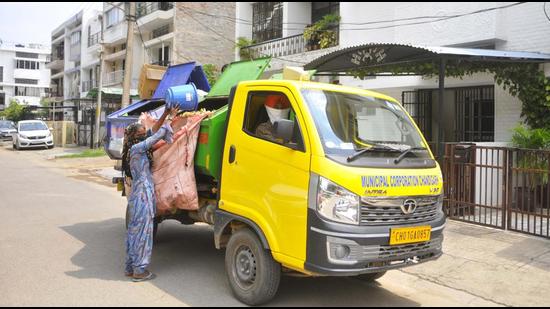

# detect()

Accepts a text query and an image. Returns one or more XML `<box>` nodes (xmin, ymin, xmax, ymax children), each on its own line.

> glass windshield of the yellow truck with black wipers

<box><xmin>302</xmin><ymin>89</ymin><xmax>426</xmax><ymax>156</ymax></box>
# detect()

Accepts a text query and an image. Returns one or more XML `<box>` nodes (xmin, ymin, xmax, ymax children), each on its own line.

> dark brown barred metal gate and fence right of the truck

<box><xmin>444</xmin><ymin>144</ymin><xmax>550</xmax><ymax>238</ymax></box>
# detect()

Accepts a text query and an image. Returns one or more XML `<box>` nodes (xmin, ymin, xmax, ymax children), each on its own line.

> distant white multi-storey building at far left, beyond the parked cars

<box><xmin>0</xmin><ymin>43</ymin><xmax>50</xmax><ymax>110</ymax></box>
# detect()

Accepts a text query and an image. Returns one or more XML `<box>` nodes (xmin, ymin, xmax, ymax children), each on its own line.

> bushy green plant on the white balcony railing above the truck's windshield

<box><xmin>304</xmin><ymin>14</ymin><xmax>340</xmax><ymax>51</ymax></box>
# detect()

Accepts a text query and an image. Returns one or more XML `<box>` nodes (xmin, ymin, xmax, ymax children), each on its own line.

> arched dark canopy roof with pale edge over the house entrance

<box><xmin>304</xmin><ymin>44</ymin><xmax>550</xmax><ymax>73</ymax></box>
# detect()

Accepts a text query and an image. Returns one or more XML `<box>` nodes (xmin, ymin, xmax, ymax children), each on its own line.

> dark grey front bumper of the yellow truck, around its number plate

<box><xmin>305</xmin><ymin>209</ymin><xmax>445</xmax><ymax>276</ymax></box>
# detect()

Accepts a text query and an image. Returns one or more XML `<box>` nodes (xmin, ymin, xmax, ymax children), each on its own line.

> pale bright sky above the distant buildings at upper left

<box><xmin>0</xmin><ymin>2</ymin><xmax>102</xmax><ymax>46</ymax></box>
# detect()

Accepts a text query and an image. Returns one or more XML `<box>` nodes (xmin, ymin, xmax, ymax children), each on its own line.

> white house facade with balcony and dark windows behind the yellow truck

<box><xmin>235</xmin><ymin>2</ymin><xmax>550</xmax><ymax>142</ymax></box>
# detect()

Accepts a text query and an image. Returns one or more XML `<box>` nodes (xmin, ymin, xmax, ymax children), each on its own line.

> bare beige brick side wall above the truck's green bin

<box><xmin>174</xmin><ymin>2</ymin><xmax>235</xmax><ymax>69</ymax></box>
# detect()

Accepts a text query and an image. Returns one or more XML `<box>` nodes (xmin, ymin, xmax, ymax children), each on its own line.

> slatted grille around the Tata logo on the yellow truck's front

<box><xmin>361</xmin><ymin>196</ymin><xmax>438</xmax><ymax>225</ymax></box>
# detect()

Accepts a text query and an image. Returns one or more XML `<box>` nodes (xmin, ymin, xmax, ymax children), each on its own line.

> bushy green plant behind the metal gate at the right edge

<box><xmin>512</xmin><ymin>125</ymin><xmax>550</xmax><ymax>211</ymax></box>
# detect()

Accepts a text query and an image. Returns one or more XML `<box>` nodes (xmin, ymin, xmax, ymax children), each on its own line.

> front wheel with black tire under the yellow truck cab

<box><xmin>225</xmin><ymin>228</ymin><xmax>281</xmax><ymax>306</ymax></box>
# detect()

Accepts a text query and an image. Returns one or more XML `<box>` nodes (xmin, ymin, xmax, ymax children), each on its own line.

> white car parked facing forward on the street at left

<box><xmin>13</xmin><ymin>120</ymin><xmax>53</xmax><ymax>150</ymax></box>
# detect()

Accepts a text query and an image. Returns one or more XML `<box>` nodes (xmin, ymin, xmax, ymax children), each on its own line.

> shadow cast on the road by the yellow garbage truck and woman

<box><xmin>62</xmin><ymin>218</ymin><xmax>420</xmax><ymax>307</ymax></box>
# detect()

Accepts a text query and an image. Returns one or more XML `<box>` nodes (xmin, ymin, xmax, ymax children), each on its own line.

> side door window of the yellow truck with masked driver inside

<box><xmin>243</xmin><ymin>91</ymin><xmax>303</xmax><ymax>148</ymax></box>
